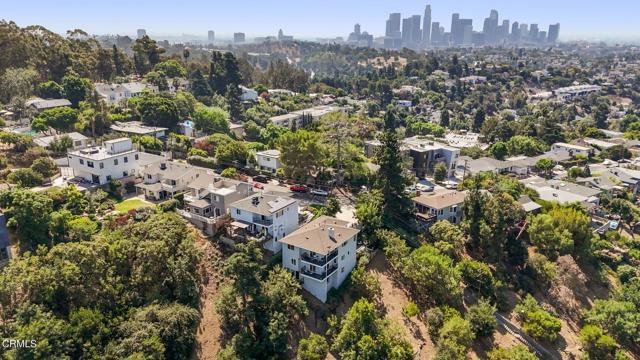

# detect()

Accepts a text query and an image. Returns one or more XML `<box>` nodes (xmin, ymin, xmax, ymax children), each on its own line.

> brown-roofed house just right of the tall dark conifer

<box><xmin>412</xmin><ymin>190</ymin><xmax>467</xmax><ymax>230</ymax></box>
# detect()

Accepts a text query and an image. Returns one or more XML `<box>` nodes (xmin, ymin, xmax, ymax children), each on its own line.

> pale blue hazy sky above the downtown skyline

<box><xmin>5</xmin><ymin>0</ymin><xmax>640</xmax><ymax>39</ymax></box>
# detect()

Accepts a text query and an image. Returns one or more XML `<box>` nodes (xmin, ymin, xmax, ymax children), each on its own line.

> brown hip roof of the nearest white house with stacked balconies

<box><xmin>280</xmin><ymin>215</ymin><xmax>360</xmax><ymax>255</ymax></box>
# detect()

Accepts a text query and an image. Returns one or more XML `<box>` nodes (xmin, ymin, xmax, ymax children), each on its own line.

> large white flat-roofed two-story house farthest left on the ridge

<box><xmin>67</xmin><ymin>138</ymin><xmax>140</xmax><ymax>185</ymax></box>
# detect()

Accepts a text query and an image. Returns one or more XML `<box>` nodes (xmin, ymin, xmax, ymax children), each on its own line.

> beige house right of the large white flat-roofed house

<box><xmin>136</xmin><ymin>160</ymin><xmax>213</xmax><ymax>201</ymax></box>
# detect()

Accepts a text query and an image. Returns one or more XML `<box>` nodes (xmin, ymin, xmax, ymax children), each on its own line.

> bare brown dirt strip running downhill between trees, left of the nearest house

<box><xmin>191</xmin><ymin>232</ymin><xmax>223</xmax><ymax>360</ymax></box>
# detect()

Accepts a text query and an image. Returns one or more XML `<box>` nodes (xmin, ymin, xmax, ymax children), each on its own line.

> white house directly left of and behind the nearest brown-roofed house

<box><xmin>229</xmin><ymin>194</ymin><xmax>298</xmax><ymax>253</ymax></box>
